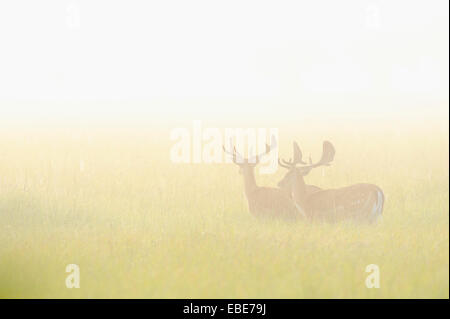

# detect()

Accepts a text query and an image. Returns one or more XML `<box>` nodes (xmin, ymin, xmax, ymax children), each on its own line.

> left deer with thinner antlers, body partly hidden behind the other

<box><xmin>223</xmin><ymin>136</ymin><xmax>301</xmax><ymax>220</ymax></box>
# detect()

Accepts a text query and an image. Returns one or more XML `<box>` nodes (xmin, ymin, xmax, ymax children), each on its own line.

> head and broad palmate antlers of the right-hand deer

<box><xmin>278</xmin><ymin>141</ymin><xmax>336</xmax><ymax>189</ymax></box>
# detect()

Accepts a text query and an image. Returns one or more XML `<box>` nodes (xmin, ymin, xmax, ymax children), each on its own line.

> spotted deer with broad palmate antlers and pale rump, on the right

<box><xmin>278</xmin><ymin>141</ymin><xmax>384</xmax><ymax>223</ymax></box>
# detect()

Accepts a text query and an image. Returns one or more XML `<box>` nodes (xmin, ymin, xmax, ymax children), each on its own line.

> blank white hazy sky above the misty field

<box><xmin>0</xmin><ymin>0</ymin><xmax>449</xmax><ymax>120</ymax></box>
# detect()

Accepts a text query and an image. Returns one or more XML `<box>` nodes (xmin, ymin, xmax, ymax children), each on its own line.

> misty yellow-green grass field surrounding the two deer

<box><xmin>0</xmin><ymin>123</ymin><xmax>449</xmax><ymax>298</ymax></box>
